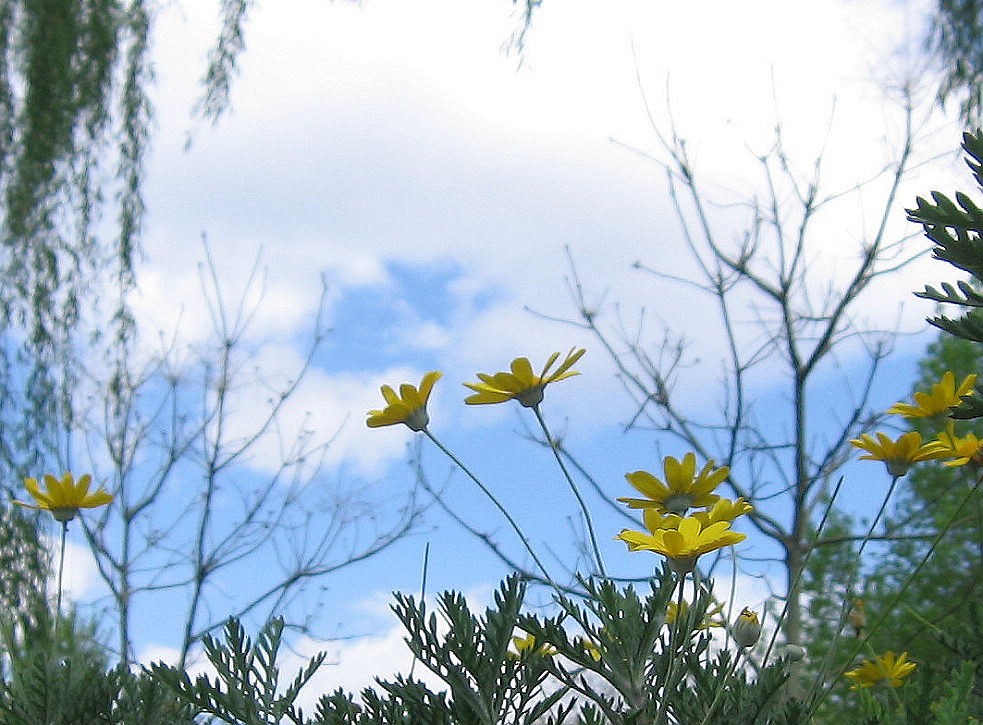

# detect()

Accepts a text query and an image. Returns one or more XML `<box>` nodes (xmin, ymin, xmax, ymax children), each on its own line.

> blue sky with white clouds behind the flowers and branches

<box><xmin>50</xmin><ymin>0</ymin><xmax>964</xmax><ymax>691</ymax></box>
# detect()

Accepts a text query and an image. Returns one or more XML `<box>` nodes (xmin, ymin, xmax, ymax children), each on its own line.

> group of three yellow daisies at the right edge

<box><xmin>850</xmin><ymin>372</ymin><xmax>983</xmax><ymax>478</ymax></box>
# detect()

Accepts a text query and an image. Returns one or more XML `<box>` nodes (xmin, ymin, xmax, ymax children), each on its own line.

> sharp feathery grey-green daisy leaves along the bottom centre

<box><xmin>146</xmin><ymin>570</ymin><xmax>806</xmax><ymax>725</ymax></box>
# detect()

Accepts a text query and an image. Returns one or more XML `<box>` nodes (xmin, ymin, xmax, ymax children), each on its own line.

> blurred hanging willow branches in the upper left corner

<box><xmin>0</xmin><ymin>0</ymin><xmax>251</xmax><ymax>485</ymax></box>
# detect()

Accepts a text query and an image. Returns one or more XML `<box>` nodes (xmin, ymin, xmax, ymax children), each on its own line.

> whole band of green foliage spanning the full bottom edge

<box><xmin>11</xmin><ymin>570</ymin><xmax>983</xmax><ymax>725</ymax></box>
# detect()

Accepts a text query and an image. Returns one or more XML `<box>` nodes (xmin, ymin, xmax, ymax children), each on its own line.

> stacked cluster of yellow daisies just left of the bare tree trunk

<box><xmin>615</xmin><ymin>453</ymin><xmax>753</xmax><ymax>574</ymax></box>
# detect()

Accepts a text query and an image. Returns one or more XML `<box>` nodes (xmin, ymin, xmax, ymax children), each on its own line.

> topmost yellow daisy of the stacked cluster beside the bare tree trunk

<box><xmin>618</xmin><ymin>453</ymin><xmax>730</xmax><ymax>516</ymax></box>
